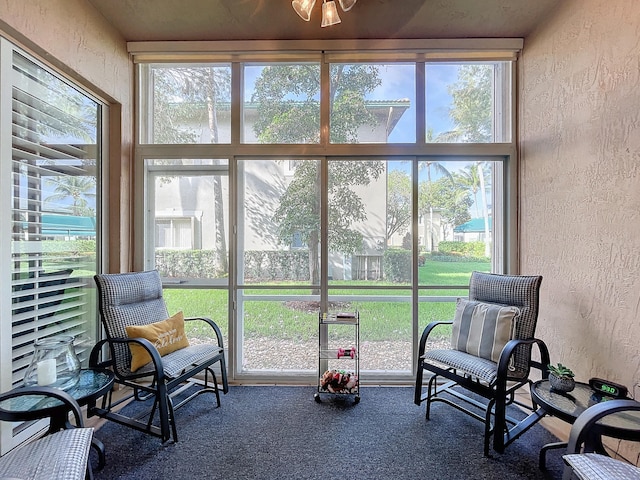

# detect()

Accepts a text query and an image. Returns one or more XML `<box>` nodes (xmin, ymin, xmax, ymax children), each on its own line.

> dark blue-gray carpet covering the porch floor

<box><xmin>92</xmin><ymin>386</ymin><xmax>562</xmax><ymax>480</ymax></box>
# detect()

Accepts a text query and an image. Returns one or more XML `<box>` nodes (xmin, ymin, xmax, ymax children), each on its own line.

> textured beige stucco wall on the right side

<box><xmin>519</xmin><ymin>0</ymin><xmax>640</xmax><ymax>395</ymax></box>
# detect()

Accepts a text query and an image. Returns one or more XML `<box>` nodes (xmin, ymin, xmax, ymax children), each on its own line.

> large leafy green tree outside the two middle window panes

<box><xmin>251</xmin><ymin>64</ymin><xmax>385</xmax><ymax>283</ymax></box>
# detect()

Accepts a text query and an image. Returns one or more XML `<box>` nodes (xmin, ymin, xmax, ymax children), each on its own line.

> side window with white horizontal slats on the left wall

<box><xmin>0</xmin><ymin>40</ymin><xmax>104</xmax><ymax>450</ymax></box>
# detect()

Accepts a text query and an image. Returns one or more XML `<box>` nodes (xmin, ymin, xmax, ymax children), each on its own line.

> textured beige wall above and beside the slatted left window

<box><xmin>0</xmin><ymin>0</ymin><xmax>134</xmax><ymax>271</ymax></box>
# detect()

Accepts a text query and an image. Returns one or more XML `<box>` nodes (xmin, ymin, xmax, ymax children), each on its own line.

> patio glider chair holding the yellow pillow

<box><xmin>89</xmin><ymin>270</ymin><xmax>229</xmax><ymax>443</ymax></box>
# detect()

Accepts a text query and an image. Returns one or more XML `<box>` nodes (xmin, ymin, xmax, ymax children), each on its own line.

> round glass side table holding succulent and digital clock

<box><xmin>531</xmin><ymin>380</ymin><xmax>640</xmax><ymax>470</ymax></box>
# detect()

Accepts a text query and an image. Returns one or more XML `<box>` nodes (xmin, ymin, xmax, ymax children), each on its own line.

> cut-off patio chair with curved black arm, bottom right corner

<box><xmin>562</xmin><ymin>400</ymin><xmax>640</xmax><ymax>480</ymax></box>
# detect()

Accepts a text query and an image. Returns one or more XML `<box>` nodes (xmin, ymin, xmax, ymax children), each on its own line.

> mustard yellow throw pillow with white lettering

<box><xmin>127</xmin><ymin>312</ymin><xmax>189</xmax><ymax>372</ymax></box>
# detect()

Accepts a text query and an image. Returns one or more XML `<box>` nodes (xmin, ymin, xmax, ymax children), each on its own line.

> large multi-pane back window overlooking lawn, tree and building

<box><xmin>137</xmin><ymin>43</ymin><xmax>515</xmax><ymax>383</ymax></box>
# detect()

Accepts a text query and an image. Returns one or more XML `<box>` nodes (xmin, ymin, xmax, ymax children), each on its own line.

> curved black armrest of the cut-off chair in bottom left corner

<box><xmin>0</xmin><ymin>386</ymin><xmax>84</xmax><ymax>427</ymax></box>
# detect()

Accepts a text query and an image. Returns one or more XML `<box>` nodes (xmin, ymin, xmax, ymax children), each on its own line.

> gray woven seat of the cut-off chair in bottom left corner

<box><xmin>0</xmin><ymin>428</ymin><xmax>93</xmax><ymax>480</ymax></box>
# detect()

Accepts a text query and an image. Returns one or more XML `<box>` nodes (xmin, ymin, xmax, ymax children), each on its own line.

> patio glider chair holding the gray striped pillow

<box><xmin>414</xmin><ymin>272</ymin><xmax>549</xmax><ymax>456</ymax></box>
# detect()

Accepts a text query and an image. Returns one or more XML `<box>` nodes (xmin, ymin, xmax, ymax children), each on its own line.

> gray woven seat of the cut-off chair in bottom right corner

<box><xmin>562</xmin><ymin>453</ymin><xmax>640</xmax><ymax>480</ymax></box>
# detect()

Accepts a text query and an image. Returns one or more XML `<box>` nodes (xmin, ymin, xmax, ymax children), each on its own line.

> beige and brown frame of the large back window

<box><xmin>128</xmin><ymin>39</ymin><xmax>523</xmax><ymax>382</ymax></box>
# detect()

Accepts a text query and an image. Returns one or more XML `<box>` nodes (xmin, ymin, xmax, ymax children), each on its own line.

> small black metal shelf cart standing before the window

<box><xmin>314</xmin><ymin>311</ymin><xmax>360</xmax><ymax>403</ymax></box>
